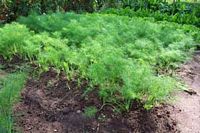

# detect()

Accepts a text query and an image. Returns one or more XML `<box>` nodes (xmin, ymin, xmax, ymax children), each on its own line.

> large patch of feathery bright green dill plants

<box><xmin>0</xmin><ymin>13</ymin><xmax>196</xmax><ymax>111</ymax></box>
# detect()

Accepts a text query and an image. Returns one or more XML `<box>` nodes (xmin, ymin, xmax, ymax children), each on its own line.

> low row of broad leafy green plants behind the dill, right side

<box><xmin>101</xmin><ymin>6</ymin><xmax>200</xmax><ymax>27</ymax></box>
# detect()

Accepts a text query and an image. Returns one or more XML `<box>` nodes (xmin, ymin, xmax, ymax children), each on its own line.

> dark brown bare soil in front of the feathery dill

<box><xmin>14</xmin><ymin>71</ymin><xmax>179</xmax><ymax>133</ymax></box>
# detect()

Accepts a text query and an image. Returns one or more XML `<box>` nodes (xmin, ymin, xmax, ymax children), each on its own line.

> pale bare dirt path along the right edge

<box><xmin>172</xmin><ymin>52</ymin><xmax>200</xmax><ymax>133</ymax></box>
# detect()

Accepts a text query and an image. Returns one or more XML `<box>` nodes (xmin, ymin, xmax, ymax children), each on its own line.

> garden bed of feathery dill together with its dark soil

<box><xmin>0</xmin><ymin>13</ymin><xmax>198</xmax><ymax>133</ymax></box>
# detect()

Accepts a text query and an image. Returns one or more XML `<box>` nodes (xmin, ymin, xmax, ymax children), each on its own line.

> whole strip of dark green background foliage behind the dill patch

<box><xmin>0</xmin><ymin>0</ymin><xmax>200</xmax><ymax>27</ymax></box>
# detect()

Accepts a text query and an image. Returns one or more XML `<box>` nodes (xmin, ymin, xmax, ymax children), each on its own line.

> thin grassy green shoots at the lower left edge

<box><xmin>0</xmin><ymin>72</ymin><xmax>26</xmax><ymax>133</ymax></box>
